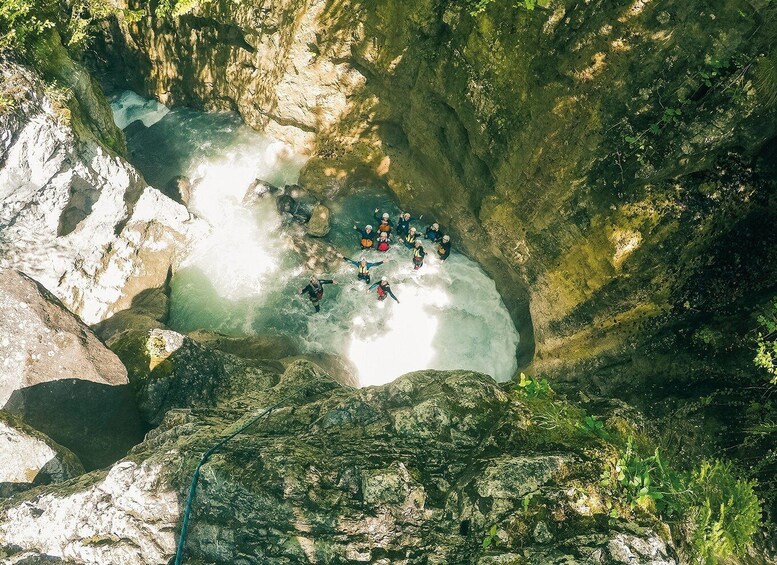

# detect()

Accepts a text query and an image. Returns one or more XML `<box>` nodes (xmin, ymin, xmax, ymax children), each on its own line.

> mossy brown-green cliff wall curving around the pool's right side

<box><xmin>97</xmin><ymin>0</ymin><xmax>777</xmax><ymax>391</ymax></box>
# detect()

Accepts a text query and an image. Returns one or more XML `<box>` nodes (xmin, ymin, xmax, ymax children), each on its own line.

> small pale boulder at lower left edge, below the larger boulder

<box><xmin>0</xmin><ymin>410</ymin><xmax>84</xmax><ymax>496</ymax></box>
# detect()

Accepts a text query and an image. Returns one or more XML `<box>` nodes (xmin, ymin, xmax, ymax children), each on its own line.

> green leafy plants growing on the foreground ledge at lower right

<box><xmin>512</xmin><ymin>374</ymin><xmax>760</xmax><ymax>564</ymax></box>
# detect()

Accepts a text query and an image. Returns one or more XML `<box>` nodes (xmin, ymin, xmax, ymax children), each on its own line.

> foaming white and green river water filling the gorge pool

<box><xmin>114</xmin><ymin>93</ymin><xmax>519</xmax><ymax>386</ymax></box>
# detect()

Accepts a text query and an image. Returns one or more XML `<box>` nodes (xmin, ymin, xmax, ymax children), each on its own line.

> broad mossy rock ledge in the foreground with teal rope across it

<box><xmin>0</xmin><ymin>361</ymin><xmax>677</xmax><ymax>565</ymax></box>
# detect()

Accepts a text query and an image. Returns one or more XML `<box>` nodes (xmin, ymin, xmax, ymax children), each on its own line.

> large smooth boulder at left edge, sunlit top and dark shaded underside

<box><xmin>0</xmin><ymin>269</ymin><xmax>144</xmax><ymax>468</ymax></box>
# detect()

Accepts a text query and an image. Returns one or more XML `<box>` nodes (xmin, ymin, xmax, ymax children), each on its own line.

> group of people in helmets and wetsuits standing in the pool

<box><xmin>299</xmin><ymin>208</ymin><xmax>451</xmax><ymax>312</ymax></box>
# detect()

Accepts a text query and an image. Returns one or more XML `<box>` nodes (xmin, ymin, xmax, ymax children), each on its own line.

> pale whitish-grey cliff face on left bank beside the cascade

<box><xmin>0</xmin><ymin>53</ymin><xmax>205</xmax><ymax>323</ymax></box>
